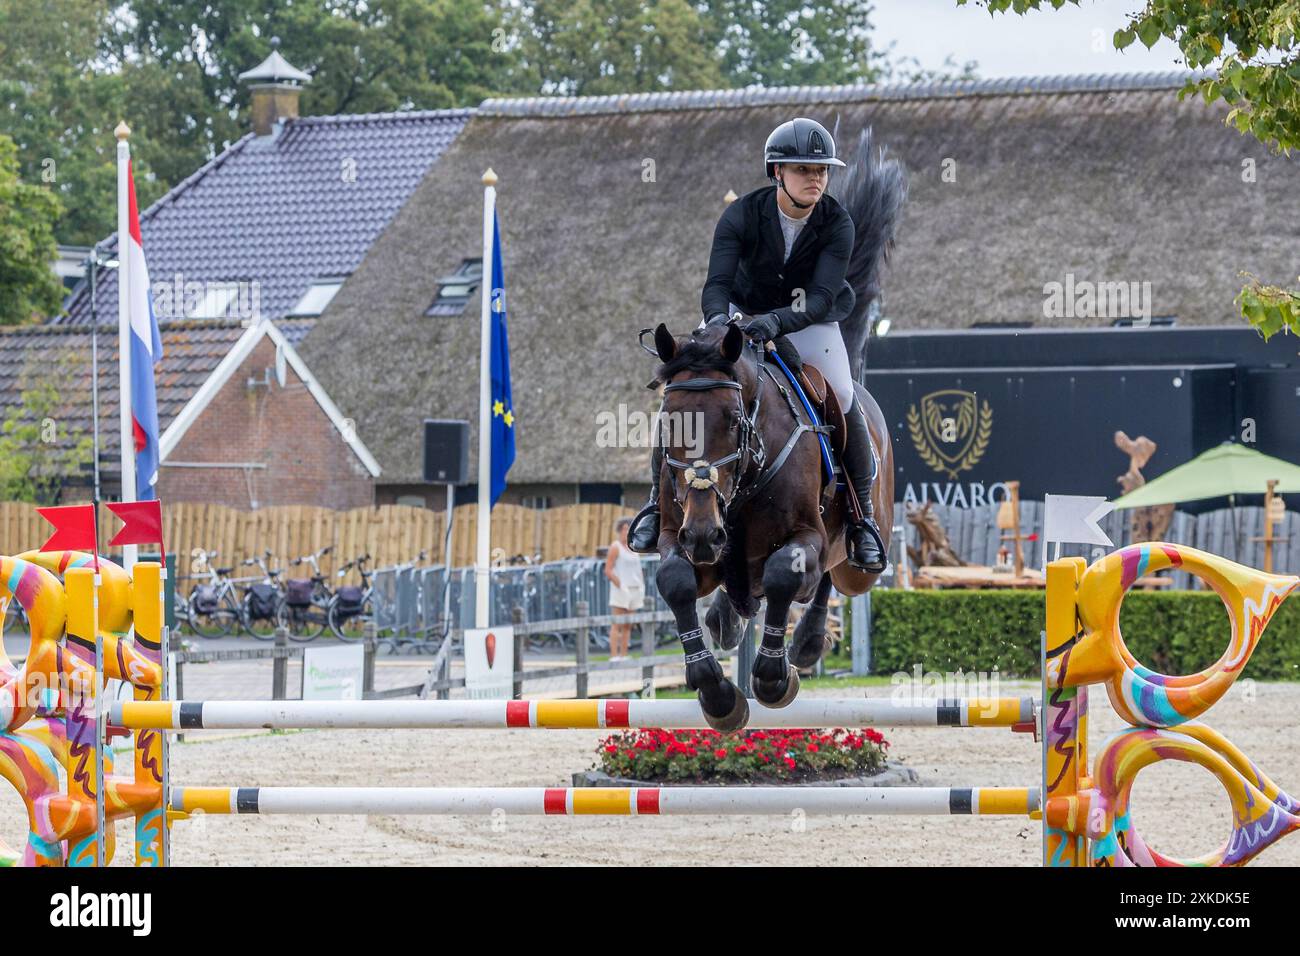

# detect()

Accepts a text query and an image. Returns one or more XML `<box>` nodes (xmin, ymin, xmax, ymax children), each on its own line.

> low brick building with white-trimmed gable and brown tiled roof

<box><xmin>0</xmin><ymin>319</ymin><xmax>380</xmax><ymax>510</ymax></box>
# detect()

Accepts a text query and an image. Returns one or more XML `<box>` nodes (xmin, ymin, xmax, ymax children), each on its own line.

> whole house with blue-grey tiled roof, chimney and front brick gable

<box><xmin>34</xmin><ymin>46</ymin><xmax>473</xmax><ymax>509</ymax></box>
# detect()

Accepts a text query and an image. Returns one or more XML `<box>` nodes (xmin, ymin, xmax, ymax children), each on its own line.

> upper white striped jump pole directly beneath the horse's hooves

<box><xmin>111</xmin><ymin>697</ymin><xmax>1036</xmax><ymax>731</ymax></box>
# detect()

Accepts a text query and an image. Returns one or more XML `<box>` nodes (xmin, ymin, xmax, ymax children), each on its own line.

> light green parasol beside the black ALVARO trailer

<box><xmin>1115</xmin><ymin>442</ymin><xmax>1300</xmax><ymax>510</ymax></box>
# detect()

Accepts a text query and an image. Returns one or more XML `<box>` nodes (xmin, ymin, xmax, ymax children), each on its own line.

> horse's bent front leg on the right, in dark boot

<box><xmin>753</xmin><ymin>529</ymin><xmax>826</xmax><ymax>708</ymax></box>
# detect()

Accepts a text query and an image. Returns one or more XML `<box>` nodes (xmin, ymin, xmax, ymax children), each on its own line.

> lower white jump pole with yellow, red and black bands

<box><xmin>170</xmin><ymin>787</ymin><xmax>1040</xmax><ymax>817</ymax></box>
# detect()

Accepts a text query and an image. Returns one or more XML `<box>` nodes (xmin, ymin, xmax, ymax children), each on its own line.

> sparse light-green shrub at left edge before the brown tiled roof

<box><xmin>0</xmin><ymin>351</ymin><xmax>92</xmax><ymax>505</ymax></box>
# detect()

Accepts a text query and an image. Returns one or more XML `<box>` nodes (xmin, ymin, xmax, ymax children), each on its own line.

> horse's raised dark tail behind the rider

<box><xmin>829</xmin><ymin>120</ymin><xmax>907</xmax><ymax>381</ymax></box>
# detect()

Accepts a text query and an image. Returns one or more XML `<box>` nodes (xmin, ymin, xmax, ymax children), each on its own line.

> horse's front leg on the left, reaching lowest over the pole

<box><xmin>655</xmin><ymin>550</ymin><xmax>749</xmax><ymax>731</ymax></box>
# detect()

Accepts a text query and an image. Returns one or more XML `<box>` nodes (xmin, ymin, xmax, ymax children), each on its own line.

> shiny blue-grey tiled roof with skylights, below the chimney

<box><xmin>51</xmin><ymin>109</ymin><xmax>473</xmax><ymax>334</ymax></box>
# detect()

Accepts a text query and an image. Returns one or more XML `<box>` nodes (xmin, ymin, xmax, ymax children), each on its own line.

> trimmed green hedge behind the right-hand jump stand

<box><xmin>871</xmin><ymin>591</ymin><xmax>1300</xmax><ymax>680</ymax></box>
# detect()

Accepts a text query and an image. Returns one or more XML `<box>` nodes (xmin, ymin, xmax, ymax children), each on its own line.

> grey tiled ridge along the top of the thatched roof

<box><xmin>478</xmin><ymin>70</ymin><xmax>1210</xmax><ymax>117</ymax></box>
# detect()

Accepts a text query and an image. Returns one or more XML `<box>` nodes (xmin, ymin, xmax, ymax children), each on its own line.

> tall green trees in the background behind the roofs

<box><xmin>0</xmin><ymin>0</ymin><xmax>971</xmax><ymax>246</ymax></box>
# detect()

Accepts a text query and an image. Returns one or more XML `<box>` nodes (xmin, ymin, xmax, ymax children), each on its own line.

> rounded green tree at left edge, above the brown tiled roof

<box><xmin>0</xmin><ymin>134</ymin><xmax>64</xmax><ymax>325</ymax></box>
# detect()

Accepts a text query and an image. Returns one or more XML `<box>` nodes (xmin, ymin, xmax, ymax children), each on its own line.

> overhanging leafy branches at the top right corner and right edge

<box><xmin>957</xmin><ymin>0</ymin><xmax>1300</xmax><ymax>338</ymax></box>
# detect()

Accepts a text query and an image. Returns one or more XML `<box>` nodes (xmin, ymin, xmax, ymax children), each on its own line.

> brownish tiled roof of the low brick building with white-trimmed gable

<box><xmin>0</xmin><ymin>319</ymin><xmax>246</xmax><ymax>455</ymax></box>
